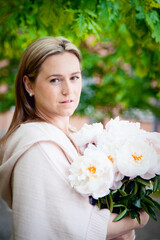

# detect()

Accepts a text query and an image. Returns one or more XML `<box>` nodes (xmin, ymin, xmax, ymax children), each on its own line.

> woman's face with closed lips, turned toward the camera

<box><xmin>32</xmin><ymin>52</ymin><xmax>81</xmax><ymax>120</ymax></box>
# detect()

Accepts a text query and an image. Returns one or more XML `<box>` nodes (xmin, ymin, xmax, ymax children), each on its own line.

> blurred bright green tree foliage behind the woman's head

<box><xmin>0</xmin><ymin>0</ymin><xmax>160</xmax><ymax>117</ymax></box>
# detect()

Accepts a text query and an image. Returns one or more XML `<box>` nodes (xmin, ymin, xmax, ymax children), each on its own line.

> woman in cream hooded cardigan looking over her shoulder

<box><xmin>0</xmin><ymin>37</ymin><xmax>148</xmax><ymax>240</ymax></box>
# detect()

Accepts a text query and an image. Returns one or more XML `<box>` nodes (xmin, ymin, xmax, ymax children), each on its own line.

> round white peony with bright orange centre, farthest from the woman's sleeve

<box><xmin>117</xmin><ymin>138</ymin><xmax>157</xmax><ymax>177</ymax></box>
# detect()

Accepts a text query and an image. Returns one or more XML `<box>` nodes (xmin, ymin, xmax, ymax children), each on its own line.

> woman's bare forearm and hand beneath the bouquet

<box><xmin>107</xmin><ymin>211</ymin><xmax>149</xmax><ymax>240</ymax></box>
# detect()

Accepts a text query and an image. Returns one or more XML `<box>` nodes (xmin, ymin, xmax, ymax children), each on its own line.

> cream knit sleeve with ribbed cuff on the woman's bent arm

<box><xmin>12</xmin><ymin>142</ymin><xmax>110</xmax><ymax>240</ymax></box>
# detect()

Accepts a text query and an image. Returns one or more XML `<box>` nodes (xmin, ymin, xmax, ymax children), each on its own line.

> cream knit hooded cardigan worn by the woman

<box><xmin>0</xmin><ymin>122</ymin><xmax>110</xmax><ymax>240</ymax></box>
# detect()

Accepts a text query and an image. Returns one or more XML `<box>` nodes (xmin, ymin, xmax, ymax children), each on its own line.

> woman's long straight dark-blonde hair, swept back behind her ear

<box><xmin>0</xmin><ymin>37</ymin><xmax>81</xmax><ymax>144</ymax></box>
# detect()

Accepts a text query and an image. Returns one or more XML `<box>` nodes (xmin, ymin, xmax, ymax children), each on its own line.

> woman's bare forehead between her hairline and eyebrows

<box><xmin>41</xmin><ymin>52</ymin><xmax>81</xmax><ymax>74</ymax></box>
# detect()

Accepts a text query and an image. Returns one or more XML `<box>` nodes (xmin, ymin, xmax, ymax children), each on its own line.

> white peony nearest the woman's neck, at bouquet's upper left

<box><xmin>70</xmin><ymin>123</ymin><xmax>103</xmax><ymax>153</ymax></box>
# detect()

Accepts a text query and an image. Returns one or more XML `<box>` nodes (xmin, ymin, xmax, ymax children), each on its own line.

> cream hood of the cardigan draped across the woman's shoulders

<box><xmin>4</xmin><ymin>122</ymin><xmax>77</xmax><ymax>164</ymax></box>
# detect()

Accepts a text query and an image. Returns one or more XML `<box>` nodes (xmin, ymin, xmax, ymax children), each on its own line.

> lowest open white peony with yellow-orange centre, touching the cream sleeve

<box><xmin>69</xmin><ymin>148</ymin><xmax>114</xmax><ymax>199</ymax></box>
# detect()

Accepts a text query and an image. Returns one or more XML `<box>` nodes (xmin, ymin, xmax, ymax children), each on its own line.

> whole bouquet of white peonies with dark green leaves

<box><xmin>69</xmin><ymin>117</ymin><xmax>160</xmax><ymax>222</ymax></box>
